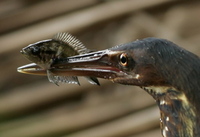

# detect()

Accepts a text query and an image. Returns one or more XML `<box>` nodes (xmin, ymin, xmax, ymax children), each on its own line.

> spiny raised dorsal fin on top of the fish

<box><xmin>53</xmin><ymin>32</ymin><xmax>88</xmax><ymax>54</ymax></box>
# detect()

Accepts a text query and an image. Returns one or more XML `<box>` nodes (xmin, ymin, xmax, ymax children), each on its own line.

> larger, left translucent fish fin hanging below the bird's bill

<box><xmin>47</xmin><ymin>70</ymin><xmax>80</xmax><ymax>86</ymax></box>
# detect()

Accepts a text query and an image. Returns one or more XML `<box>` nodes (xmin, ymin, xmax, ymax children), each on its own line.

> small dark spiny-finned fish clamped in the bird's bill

<box><xmin>20</xmin><ymin>32</ymin><xmax>100</xmax><ymax>85</ymax></box>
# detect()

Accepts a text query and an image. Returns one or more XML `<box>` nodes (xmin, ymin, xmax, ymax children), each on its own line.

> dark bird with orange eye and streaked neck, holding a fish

<box><xmin>20</xmin><ymin>37</ymin><xmax>200</xmax><ymax>137</ymax></box>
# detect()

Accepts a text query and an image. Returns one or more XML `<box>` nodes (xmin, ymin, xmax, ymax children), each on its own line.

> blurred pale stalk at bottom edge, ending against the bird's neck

<box><xmin>64</xmin><ymin>107</ymin><xmax>159</xmax><ymax>137</ymax></box>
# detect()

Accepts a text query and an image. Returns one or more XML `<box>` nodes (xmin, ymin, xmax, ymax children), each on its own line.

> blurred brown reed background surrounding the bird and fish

<box><xmin>0</xmin><ymin>0</ymin><xmax>200</xmax><ymax>137</ymax></box>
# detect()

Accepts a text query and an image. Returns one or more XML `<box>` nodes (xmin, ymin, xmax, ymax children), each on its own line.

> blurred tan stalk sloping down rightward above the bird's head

<box><xmin>130</xmin><ymin>12</ymin><xmax>199</xmax><ymax>54</ymax></box>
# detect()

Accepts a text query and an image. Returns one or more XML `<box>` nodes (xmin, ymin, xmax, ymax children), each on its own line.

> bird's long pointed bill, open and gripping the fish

<box><xmin>18</xmin><ymin>50</ymin><xmax>130</xmax><ymax>80</ymax></box>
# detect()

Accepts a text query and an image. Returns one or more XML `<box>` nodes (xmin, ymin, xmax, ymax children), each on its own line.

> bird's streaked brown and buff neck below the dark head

<box><xmin>143</xmin><ymin>87</ymin><xmax>200</xmax><ymax>137</ymax></box>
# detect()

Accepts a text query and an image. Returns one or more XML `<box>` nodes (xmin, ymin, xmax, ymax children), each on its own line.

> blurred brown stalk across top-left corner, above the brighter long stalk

<box><xmin>0</xmin><ymin>0</ymin><xmax>98</xmax><ymax>33</ymax></box>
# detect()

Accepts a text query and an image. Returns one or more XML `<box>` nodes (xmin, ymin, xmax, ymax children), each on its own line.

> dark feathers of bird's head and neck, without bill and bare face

<box><xmin>113</xmin><ymin>38</ymin><xmax>200</xmax><ymax>137</ymax></box>
